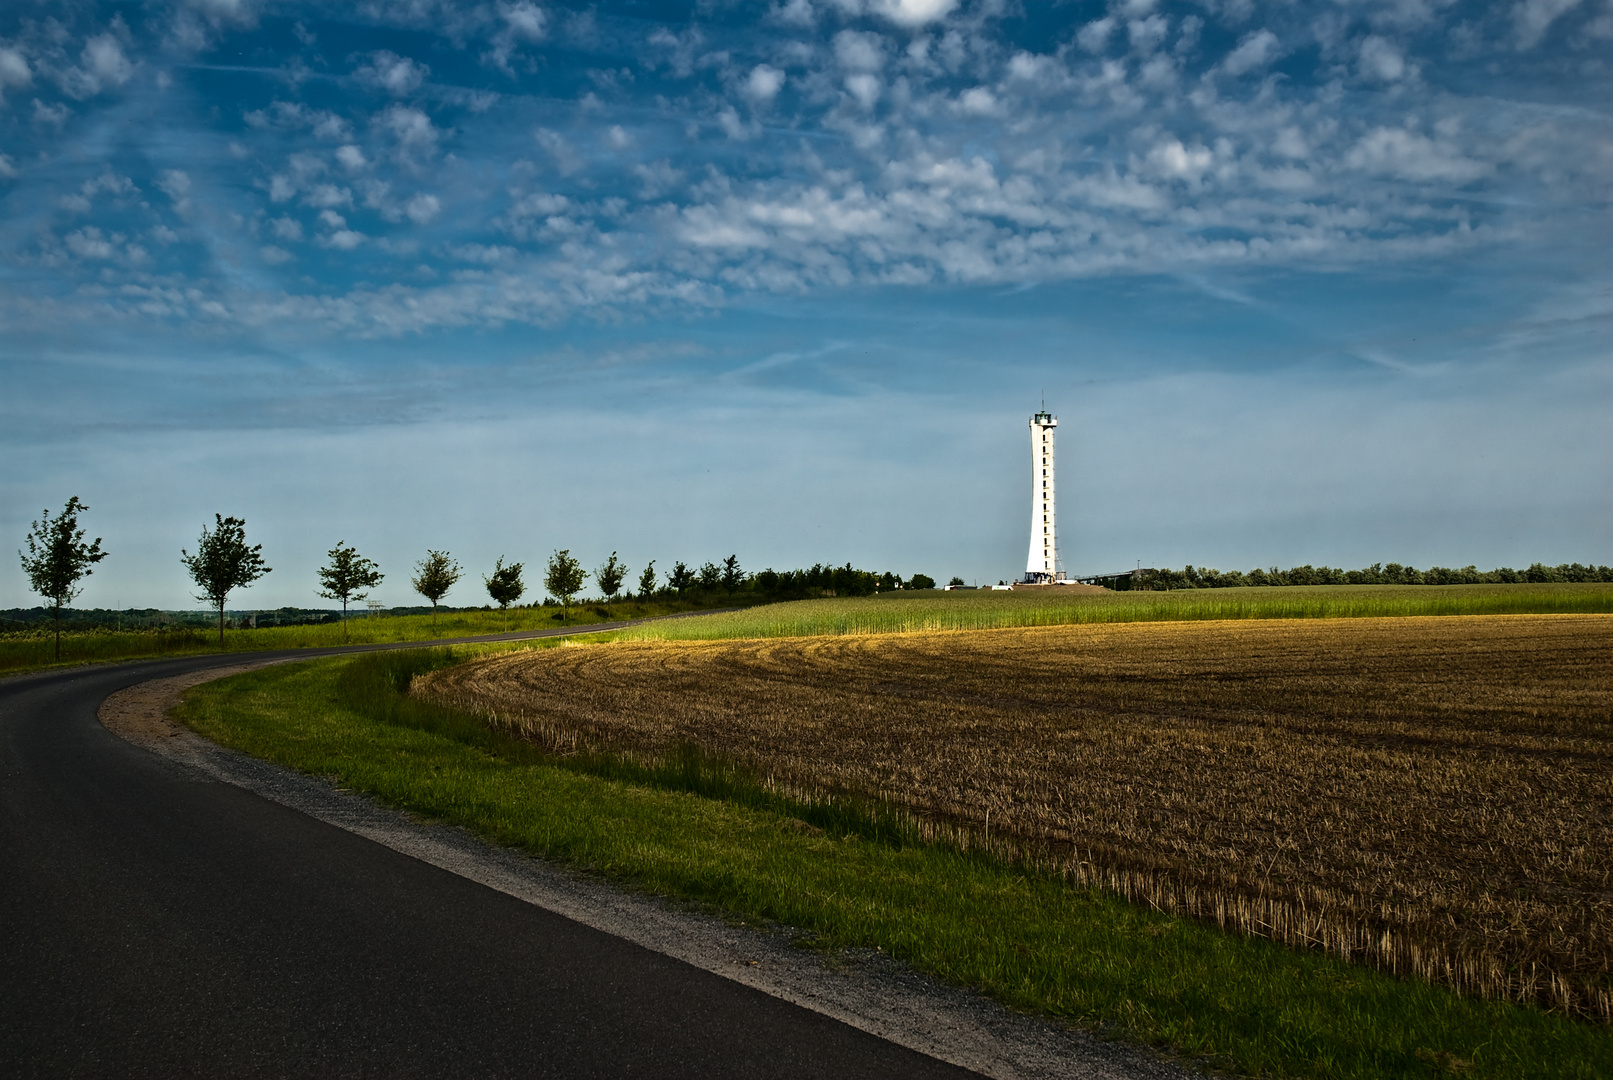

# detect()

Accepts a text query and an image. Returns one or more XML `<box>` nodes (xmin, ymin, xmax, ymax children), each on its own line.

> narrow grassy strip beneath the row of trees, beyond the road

<box><xmin>0</xmin><ymin>600</ymin><xmax>729</xmax><ymax>675</ymax></box>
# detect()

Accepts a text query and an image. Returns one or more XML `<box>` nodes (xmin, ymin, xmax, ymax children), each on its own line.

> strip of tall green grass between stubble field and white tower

<box><xmin>619</xmin><ymin>584</ymin><xmax>1613</xmax><ymax>640</ymax></box>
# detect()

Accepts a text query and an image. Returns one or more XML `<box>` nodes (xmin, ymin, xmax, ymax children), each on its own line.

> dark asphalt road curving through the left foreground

<box><xmin>0</xmin><ymin>651</ymin><xmax>973</xmax><ymax>1080</ymax></box>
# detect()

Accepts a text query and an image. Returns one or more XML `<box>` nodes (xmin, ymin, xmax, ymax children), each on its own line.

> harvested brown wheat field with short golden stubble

<box><xmin>415</xmin><ymin>616</ymin><xmax>1613</xmax><ymax>1022</ymax></box>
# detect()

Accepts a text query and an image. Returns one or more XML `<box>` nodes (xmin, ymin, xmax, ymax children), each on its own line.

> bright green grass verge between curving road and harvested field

<box><xmin>181</xmin><ymin>651</ymin><xmax>1613</xmax><ymax>1078</ymax></box>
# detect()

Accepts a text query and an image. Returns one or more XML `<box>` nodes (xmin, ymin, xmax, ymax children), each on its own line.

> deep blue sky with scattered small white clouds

<box><xmin>0</xmin><ymin>0</ymin><xmax>1613</xmax><ymax>608</ymax></box>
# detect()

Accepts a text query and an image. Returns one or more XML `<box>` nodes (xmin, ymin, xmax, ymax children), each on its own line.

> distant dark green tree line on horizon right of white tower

<box><xmin>1103</xmin><ymin>563</ymin><xmax>1613</xmax><ymax>590</ymax></box>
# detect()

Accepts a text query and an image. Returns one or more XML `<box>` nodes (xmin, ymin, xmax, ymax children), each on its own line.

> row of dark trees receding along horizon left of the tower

<box><xmin>18</xmin><ymin>495</ymin><xmax>936</xmax><ymax>659</ymax></box>
